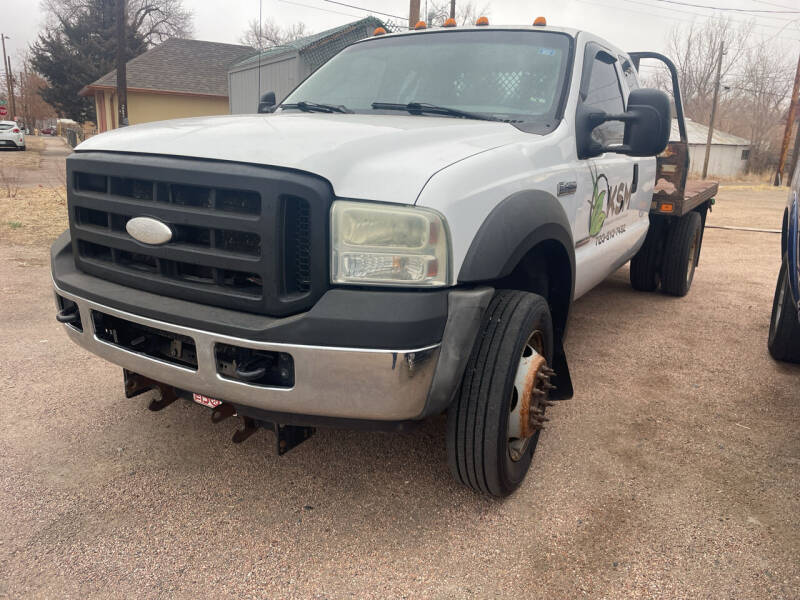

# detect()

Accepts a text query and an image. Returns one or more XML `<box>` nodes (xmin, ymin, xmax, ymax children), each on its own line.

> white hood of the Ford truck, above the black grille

<box><xmin>76</xmin><ymin>112</ymin><xmax>530</xmax><ymax>204</ymax></box>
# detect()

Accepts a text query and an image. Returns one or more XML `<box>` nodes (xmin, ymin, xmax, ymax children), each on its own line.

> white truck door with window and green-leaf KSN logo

<box><xmin>573</xmin><ymin>43</ymin><xmax>654</xmax><ymax>297</ymax></box>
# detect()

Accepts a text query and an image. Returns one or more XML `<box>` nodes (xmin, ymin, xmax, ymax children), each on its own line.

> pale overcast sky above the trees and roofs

<box><xmin>0</xmin><ymin>0</ymin><xmax>800</xmax><ymax>67</ymax></box>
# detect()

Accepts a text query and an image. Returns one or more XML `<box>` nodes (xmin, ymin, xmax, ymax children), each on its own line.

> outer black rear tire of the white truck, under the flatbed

<box><xmin>661</xmin><ymin>211</ymin><xmax>703</xmax><ymax>296</ymax></box>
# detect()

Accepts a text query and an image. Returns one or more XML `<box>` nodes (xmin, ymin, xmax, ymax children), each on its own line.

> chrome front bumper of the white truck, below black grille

<box><xmin>54</xmin><ymin>284</ymin><xmax>440</xmax><ymax>421</ymax></box>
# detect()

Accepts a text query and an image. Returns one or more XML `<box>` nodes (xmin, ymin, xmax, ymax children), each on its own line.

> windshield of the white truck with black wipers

<box><xmin>283</xmin><ymin>30</ymin><xmax>571</xmax><ymax>122</ymax></box>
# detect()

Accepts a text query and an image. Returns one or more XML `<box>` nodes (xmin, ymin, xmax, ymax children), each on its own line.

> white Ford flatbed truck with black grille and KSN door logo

<box><xmin>52</xmin><ymin>21</ymin><xmax>715</xmax><ymax>496</ymax></box>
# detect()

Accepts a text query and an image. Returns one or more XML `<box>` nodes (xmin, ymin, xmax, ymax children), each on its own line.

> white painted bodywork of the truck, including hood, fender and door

<box><xmin>76</xmin><ymin>28</ymin><xmax>656</xmax><ymax>298</ymax></box>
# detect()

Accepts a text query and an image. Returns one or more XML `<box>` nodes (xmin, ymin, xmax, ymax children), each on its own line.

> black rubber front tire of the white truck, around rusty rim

<box><xmin>447</xmin><ymin>290</ymin><xmax>553</xmax><ymax>497</ymax></box>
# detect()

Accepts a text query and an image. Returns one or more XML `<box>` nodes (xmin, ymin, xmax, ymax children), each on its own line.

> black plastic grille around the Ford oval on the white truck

<box><xmin>67</xmin><ymin>153</ymin><xmax>332</xmax><ymax>316</ymax></box>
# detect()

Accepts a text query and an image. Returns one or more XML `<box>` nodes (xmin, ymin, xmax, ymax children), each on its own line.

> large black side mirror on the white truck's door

<box><xmin>576</xmin><ymin>88</ymin><xmax>672</xmax><ymax>158</ymax></box>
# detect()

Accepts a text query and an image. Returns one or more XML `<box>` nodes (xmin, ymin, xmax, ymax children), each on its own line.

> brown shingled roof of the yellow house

<box><xmin>81</xmin><ymin>38</ymin><xmax>255</xmax><ymax>96</ymax></box>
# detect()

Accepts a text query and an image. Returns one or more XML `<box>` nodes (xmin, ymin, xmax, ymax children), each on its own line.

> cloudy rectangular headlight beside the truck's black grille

<box><xmin>331</xmin><ymin>200</ymin><xmax>450</xmax><ymax>286</ymax></box>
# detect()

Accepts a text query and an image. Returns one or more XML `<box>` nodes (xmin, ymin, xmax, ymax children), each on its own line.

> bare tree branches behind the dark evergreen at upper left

<box><xmin>42</xmin><ymin>0</ymin><xmax>192</xmax><ymax>46</ymax></box>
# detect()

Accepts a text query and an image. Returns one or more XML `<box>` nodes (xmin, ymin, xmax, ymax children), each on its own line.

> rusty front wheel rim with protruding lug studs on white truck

<box><xmin>507</xmin><ymin>329</ymin><xmax>554</xmax><ymax>462</ymax></box>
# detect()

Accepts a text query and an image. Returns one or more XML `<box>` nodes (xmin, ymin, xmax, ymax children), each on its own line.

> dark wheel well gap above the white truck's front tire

<box><xmin>494</xmin><ymin>240</ymin><xmax>573</xmax><ymax>342</ymax></box>
